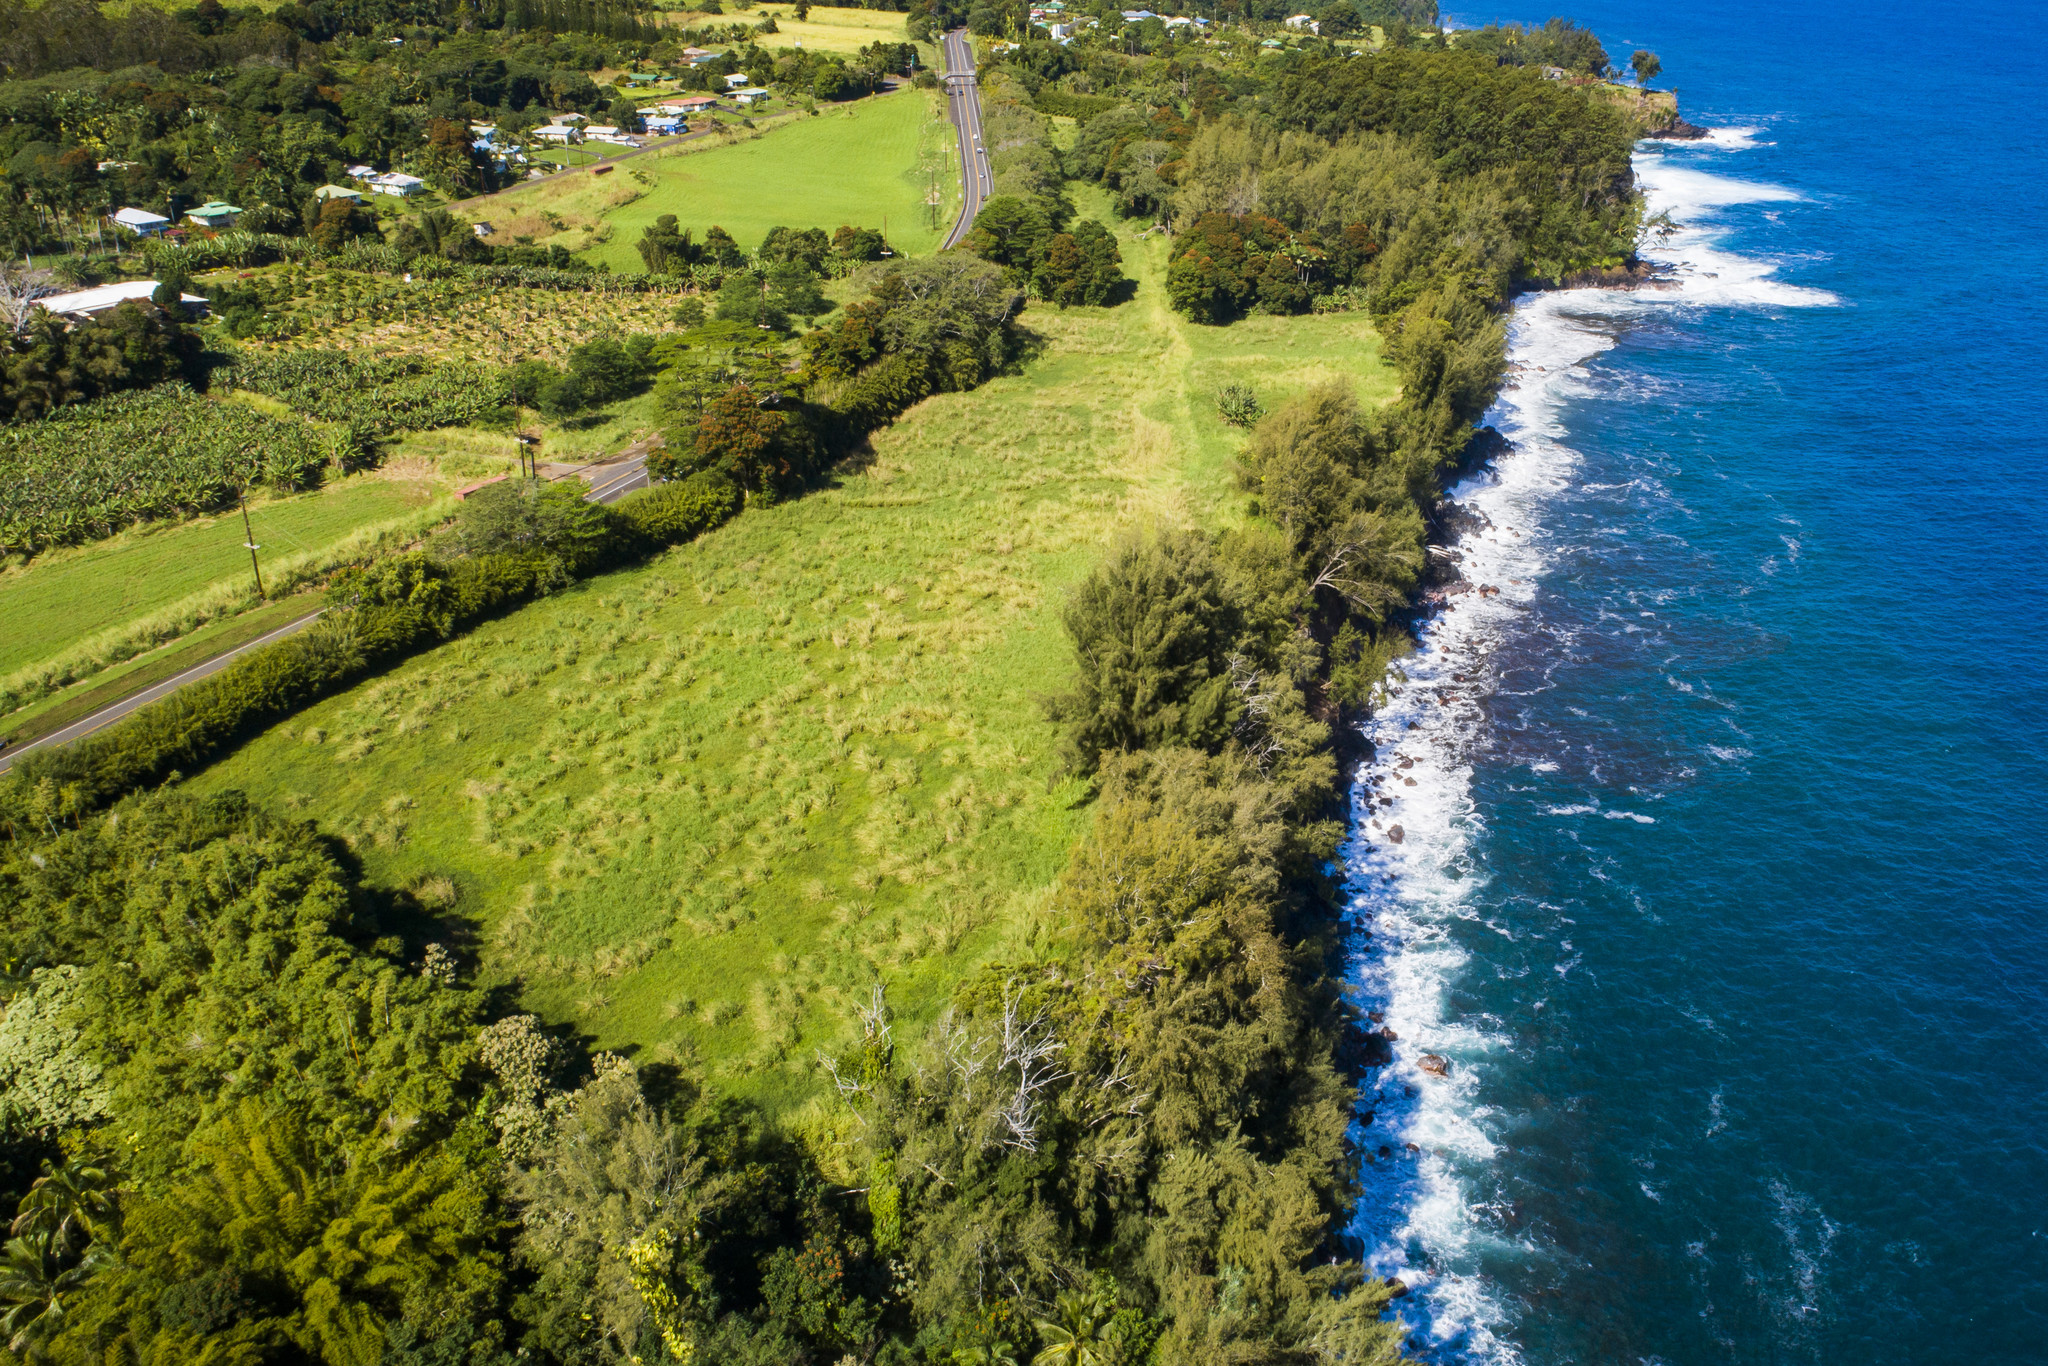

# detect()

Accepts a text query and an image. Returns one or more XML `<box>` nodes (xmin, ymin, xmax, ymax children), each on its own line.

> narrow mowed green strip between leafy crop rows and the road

<box><xmin>0</xmin><ymin>475</ymin><xmax>438</xmax><ymax>674</ymax></box>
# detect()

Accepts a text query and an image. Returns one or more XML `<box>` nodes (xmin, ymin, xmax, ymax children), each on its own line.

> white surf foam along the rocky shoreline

<box><xmin>1343</xmin><ymin>133</ymin><xmax>1837</xmax><ymax>1366</ymax></box>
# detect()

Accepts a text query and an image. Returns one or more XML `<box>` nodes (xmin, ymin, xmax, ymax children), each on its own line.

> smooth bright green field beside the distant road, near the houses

<box><xmin>584</xmin><ymin>90</ymin><xmax>958</xmax><ymax>270</ymax></box>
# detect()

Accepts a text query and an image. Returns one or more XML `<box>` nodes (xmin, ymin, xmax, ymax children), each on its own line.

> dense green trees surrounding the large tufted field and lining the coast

<box><xmin>0</xmin><ymin>0</ymin><xmax>1638</xmax><ymax>1366</ymax></box>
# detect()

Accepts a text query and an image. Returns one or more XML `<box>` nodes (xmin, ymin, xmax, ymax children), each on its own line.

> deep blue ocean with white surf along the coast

<box><xmin>1348</xmin><ymin>0</ymin><xmax>2048</xmax><ymax>1366</ymax></box>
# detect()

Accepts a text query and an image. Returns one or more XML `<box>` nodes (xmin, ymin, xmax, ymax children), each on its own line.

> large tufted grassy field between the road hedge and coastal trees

<box><xmin>190</xmin><ymin>210</ymin><xmax>1391</xmax><ymax>1110</ymax></box>
